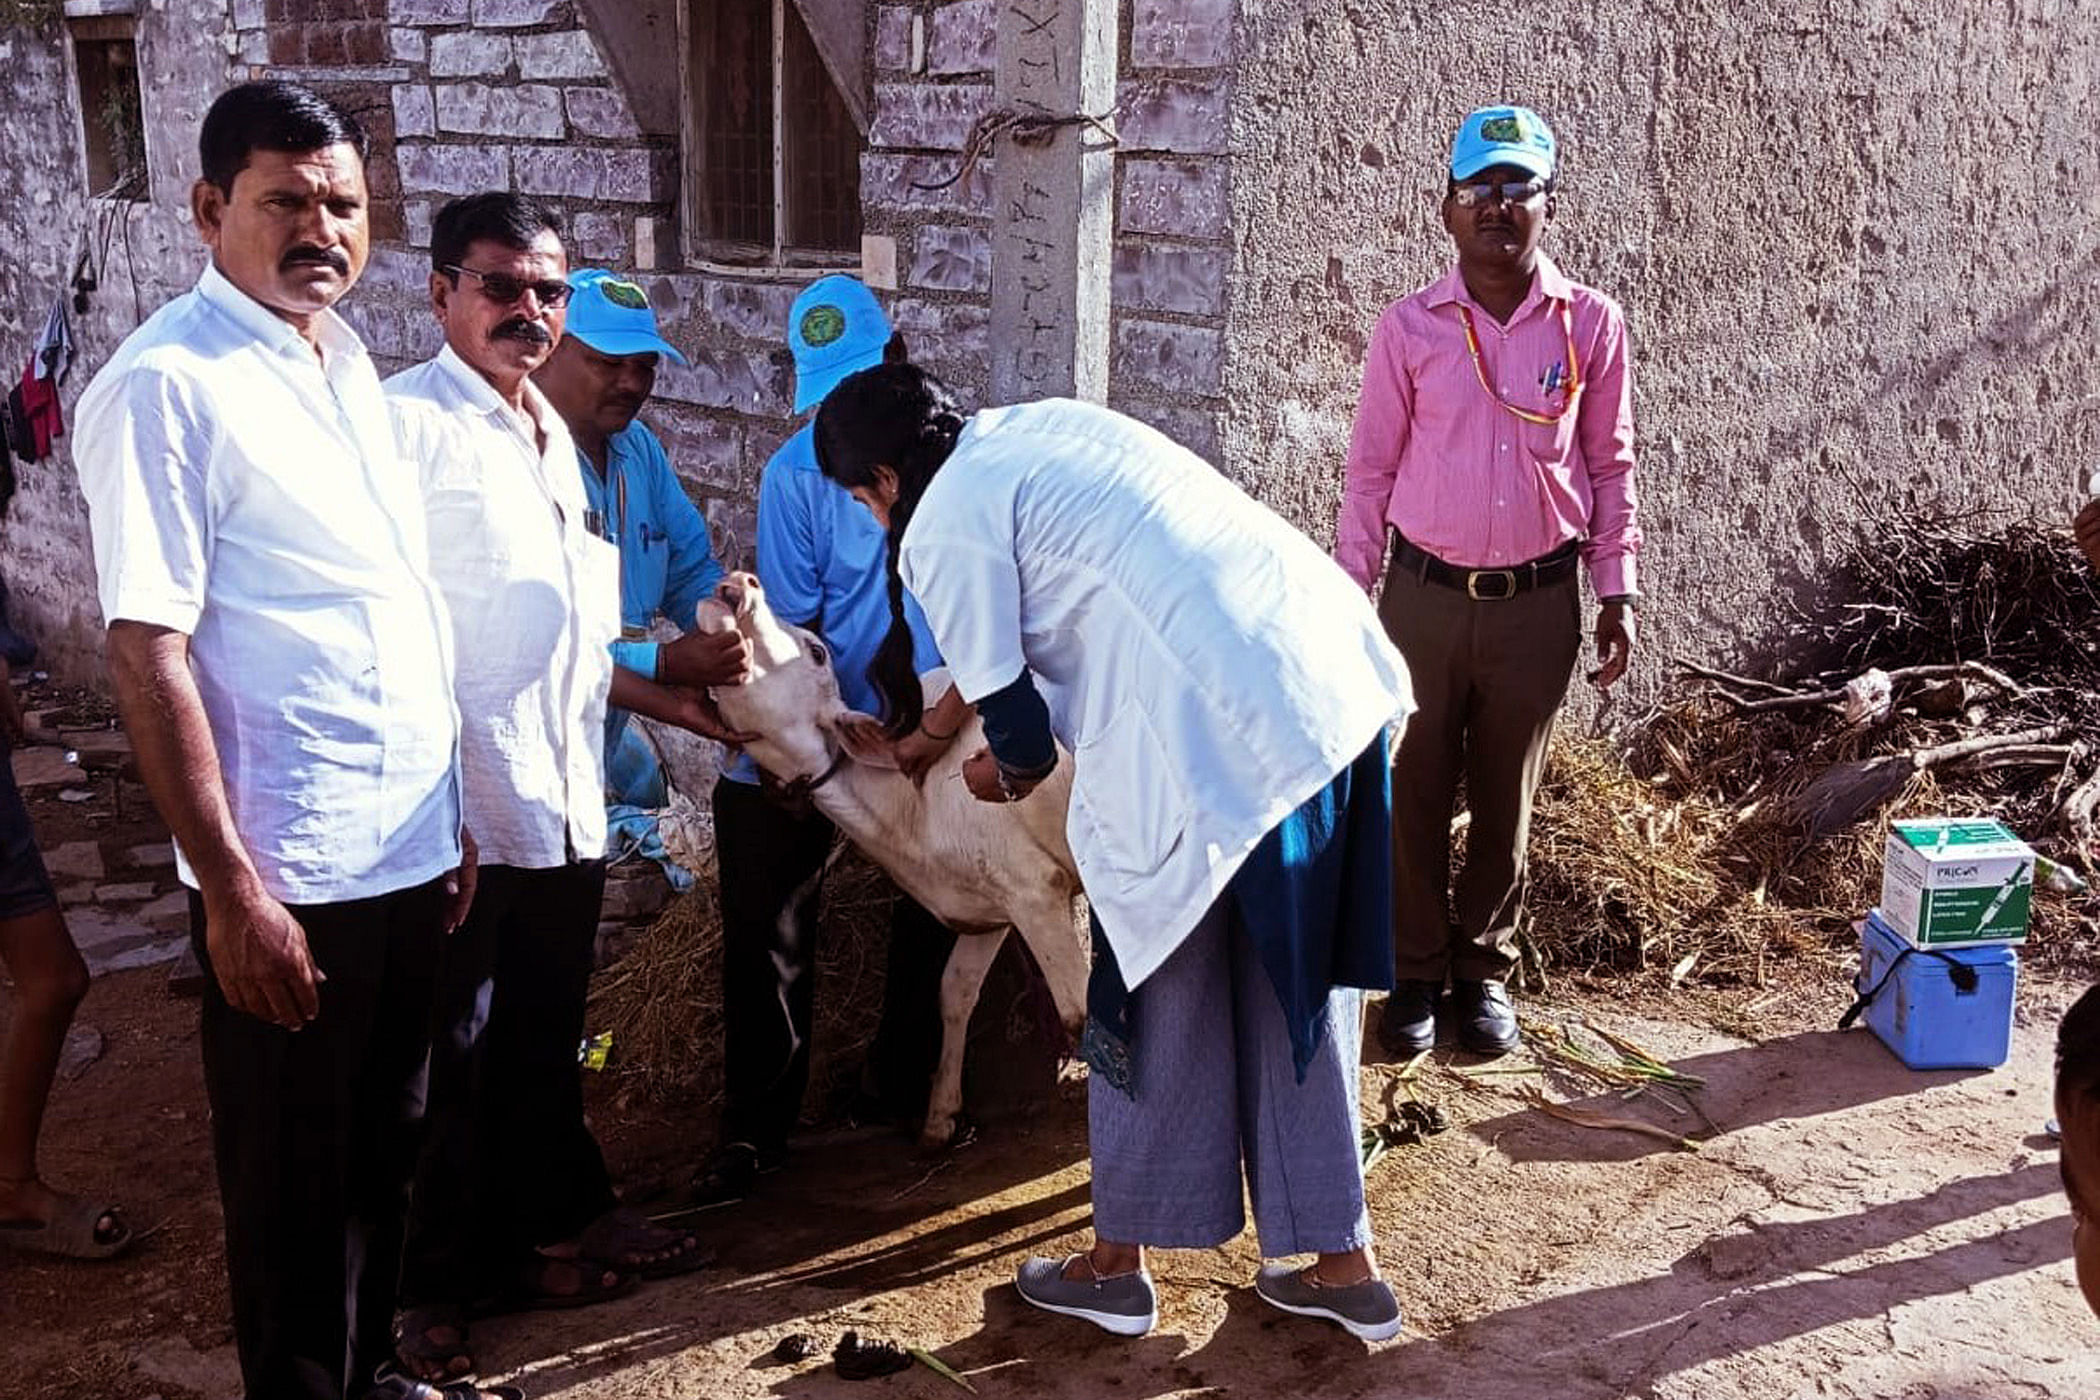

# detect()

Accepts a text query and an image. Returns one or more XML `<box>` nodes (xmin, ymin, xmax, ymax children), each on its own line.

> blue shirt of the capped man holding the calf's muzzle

<box><xmin>575</xmin><ymin>418</ymin><xmax>730</xmax><ymax>680</ymax></box>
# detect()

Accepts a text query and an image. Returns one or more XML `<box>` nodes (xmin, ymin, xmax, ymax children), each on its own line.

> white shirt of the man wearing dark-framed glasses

<box><xmin>386</xmin><ymin>344</ymin><xmax>620</xmax><ymax>869</ymax></box>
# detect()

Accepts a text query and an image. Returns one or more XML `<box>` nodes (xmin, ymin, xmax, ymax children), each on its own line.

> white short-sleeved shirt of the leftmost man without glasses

<box><xmin>74</xmin><ymin>267</ymin><xmax>460</xmax><ymax>905</ymax></box>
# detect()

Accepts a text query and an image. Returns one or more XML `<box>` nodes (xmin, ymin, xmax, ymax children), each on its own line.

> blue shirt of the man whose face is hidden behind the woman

<box><xmin>725</xmin><ymin>424</ymin><xmax>941</xmax><ymax>783</ymax></box>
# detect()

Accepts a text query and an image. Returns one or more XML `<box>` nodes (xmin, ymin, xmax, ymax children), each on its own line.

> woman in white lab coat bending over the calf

<box><xmin>817</xmin><ymin>365</ymin><xmax>1411</xmax><ymax>1339</ymax></box>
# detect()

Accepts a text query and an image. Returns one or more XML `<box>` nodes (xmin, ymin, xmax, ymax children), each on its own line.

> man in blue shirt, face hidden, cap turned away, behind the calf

<box><xmin>691</xmin><ymin>277</ymin><xmax>968</xmax><ymax>1207</ymax></box>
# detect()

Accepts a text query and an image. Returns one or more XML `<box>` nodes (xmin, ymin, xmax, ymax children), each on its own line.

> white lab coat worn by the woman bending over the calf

<box><xmin>899</xmin><ymin>399</ymin><xmax>1413</xmax><ymax>987</ymax></box>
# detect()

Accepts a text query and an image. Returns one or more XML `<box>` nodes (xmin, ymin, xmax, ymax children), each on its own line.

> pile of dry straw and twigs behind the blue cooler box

<box><xmin>1527</xmin><ymin>521</ymin><xmax>2100</xmax><ymax>984</ymax></box>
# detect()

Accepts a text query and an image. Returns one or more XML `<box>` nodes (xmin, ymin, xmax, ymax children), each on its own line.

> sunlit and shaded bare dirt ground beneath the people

<box><xmin>0</xmin><ymin>948</ymin><xmax>2100</xmax><ymax>1400</ymax></box>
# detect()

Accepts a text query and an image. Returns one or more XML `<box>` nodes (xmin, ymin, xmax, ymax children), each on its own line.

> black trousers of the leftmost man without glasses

<box><xmin>189</xmin><ymin>882</ymin><xmax>445</xmax><ymax>1400</ymax></box>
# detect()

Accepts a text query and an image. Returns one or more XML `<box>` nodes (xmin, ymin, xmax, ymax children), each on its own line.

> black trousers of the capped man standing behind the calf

<box><xmin>714</xmin><ymin>779</ymin><xmax>956</xmax><ymax>1157</ymax></box>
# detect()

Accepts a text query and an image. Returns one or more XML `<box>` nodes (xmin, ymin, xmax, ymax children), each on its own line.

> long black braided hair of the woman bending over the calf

<box><xmin>813</xmin><ymin>363</ymin><xmax>962</xmax><ymax>737</ymax></box>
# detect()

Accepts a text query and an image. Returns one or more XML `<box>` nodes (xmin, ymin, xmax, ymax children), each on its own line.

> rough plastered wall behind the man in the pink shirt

<box><xmin>1222</xmin><ymin>0</ymin><xmax>2100</xmax><ymax>682</ymax></box>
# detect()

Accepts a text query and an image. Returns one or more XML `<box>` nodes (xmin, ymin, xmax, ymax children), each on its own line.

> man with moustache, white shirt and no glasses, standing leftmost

<box><xmin>76</xmin><ymin>82</ymin><xmax>473</xmax><ymax>1400</ymax></box>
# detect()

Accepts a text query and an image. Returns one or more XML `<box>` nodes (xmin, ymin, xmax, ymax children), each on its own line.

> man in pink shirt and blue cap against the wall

<box><xmin>1334</xmin><ymin>107</ymin><xmax>1640</xmax><ymax>1054</ymax></box>
